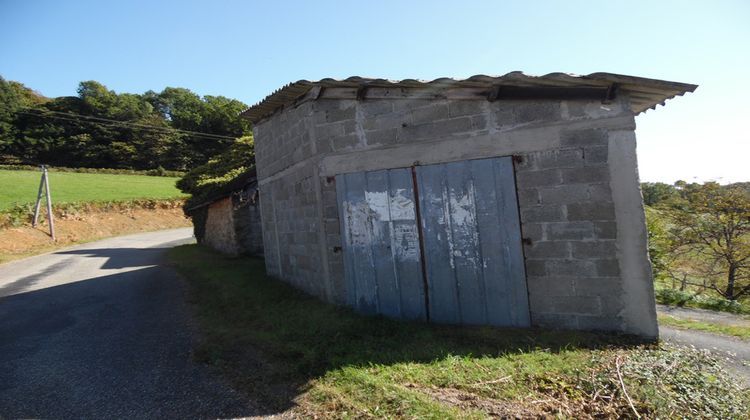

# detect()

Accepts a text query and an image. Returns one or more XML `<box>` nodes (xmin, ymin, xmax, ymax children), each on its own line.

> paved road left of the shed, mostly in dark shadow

<box><xmin>0</xmin><ymin>229</ymin><xmax>257</xmax><ymax>418</ymax></box>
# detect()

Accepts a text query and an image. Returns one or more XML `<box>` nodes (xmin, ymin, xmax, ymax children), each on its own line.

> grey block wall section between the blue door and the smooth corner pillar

<box><xmin>516</xmin><ymin>129</ymin><xmax>624</xmax><ymax>330</ymax></box>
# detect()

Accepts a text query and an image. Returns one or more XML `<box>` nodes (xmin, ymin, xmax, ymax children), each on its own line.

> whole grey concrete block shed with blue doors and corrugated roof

<box><xmin>243</xmin><ymin>72</ymin><xmax>696</xmax><ymax>338</ymax></box>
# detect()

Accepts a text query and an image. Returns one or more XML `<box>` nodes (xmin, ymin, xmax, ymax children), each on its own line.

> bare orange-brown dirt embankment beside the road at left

<box><xmin>0</xmin><ymin>206</ymin><xmax>191</xmax><ymax>263</ymax></box>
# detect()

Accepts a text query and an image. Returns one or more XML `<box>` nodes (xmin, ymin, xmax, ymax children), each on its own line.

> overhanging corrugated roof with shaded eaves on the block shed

<box><xmin>240</xmin><ymin>71</ymin><xmax>698</xmax><ymax>123</ymax></box>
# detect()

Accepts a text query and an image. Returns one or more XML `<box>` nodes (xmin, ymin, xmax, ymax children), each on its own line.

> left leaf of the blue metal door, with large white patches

<box><xmin>336</xmin><ymin>169</ymin><xmax>426</xmax><ymax>319</ymax></box>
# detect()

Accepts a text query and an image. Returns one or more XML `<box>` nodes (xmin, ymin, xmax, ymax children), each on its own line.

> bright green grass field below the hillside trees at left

<box><xmin>0</xmin><ymin>170</ymin><xmax>185</xmax><ymax>211</ymax></box>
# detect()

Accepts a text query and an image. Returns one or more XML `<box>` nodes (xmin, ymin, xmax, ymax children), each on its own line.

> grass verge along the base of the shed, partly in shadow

<box><xmin>169</xmin><ymin>245</ymin><xmax>750</xmax><ymax>418</ymax></box>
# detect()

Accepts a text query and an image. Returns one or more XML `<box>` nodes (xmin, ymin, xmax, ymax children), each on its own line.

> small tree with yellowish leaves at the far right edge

<box><xmin>668</xmin><ymin>182</ymin><xmax>750</xmax><ymax>300</ymax></box>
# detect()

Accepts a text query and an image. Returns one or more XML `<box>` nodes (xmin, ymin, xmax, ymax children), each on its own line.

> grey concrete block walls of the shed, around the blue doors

<box><xmin>255</xmin><ymin>95</ymin><xmax>657</xmax><ymax>336</ymax></box>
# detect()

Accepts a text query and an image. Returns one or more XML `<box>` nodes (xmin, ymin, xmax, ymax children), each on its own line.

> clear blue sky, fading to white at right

<box><xmin>0</xmin><ymin>0</ymin><xmax>750</xmax><ymax>183</ymax></box>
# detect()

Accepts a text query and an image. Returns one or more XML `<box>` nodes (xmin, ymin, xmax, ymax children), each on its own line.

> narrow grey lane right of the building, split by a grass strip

<box><xmin>656</xmin><ymin>305</ymin><xmax>750</xmax><ymax>386</ymax></box>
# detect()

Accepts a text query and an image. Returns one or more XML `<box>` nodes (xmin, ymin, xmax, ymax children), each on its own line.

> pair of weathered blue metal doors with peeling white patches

<box><xmin>336</xmin><ymin>157</ymin><xmax>529</xmax><ymax>327</ymax></box>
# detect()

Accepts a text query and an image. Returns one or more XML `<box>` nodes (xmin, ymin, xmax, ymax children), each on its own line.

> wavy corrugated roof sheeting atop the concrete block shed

<box><xmin>241</xmin><ymin>71</ymin><xmax>698</xmax><ymax>122</ymax></box>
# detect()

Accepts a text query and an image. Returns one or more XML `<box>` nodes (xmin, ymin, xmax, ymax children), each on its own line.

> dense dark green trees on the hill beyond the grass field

<box><xmin>0</xmin><ymin>77</ymin><xmax>251</xmax><ymax>171</ymax></box>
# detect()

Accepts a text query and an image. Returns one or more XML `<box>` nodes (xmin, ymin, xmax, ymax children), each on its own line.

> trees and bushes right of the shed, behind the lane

<box><xmin>642</xmin><ymin>181</ymin><xmax>750</xmax><ymax>301</ymax></box>
